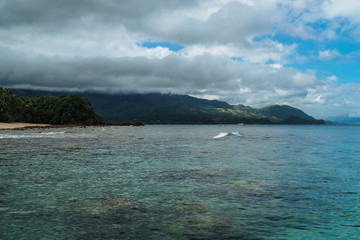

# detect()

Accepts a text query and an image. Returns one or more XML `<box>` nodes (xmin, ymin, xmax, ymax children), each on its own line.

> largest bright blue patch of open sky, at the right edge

<box><xmin>253</xmin><ymin>25</ymin><xmax>360</xmax><ymax>83</ymax></box>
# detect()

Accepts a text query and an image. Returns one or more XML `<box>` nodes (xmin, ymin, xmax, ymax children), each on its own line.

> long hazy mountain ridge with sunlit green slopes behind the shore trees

<box><xmin>13</xmin><ymin>90</ymin><xmax>324</xmax><ymax>124</ymax></box>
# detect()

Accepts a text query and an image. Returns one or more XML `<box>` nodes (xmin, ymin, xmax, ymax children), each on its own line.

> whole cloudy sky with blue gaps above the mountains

<box><xmin>0</xmin><ymin>0</ymin><xmax>360</xmax><ymax>118</ymax></box>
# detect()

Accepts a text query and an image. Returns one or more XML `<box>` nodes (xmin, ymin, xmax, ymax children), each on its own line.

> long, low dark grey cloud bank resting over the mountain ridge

<box><xmin>0</xmin><ymin>44</ymin><xmax>316</xmax><ymax>94</ymax></box>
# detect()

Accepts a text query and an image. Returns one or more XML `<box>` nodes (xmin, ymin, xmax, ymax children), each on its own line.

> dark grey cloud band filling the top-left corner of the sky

<box><xmin>0</xmin><ymin>0</ymin><xmax>197</xmax><ymax>28</ymax></box>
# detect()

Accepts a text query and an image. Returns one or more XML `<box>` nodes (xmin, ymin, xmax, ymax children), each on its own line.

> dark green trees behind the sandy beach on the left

<box><xmin>0</xmin><ymin>87</ymin><xmax>103</xmax><ymax>125</ymax></box>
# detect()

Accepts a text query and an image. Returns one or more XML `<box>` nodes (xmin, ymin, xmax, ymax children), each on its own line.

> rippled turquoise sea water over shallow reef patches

<box><xmin>0</xmin><ymin>125</ymin><xmax>360</xmax><ymax>239</ymax></box>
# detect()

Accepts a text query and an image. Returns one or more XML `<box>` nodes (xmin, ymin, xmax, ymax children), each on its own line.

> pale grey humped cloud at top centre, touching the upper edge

<box><xmin>146</xmin><ymin>2</ymin><xmax>271</xmax><ymax>45</ymax></box>
